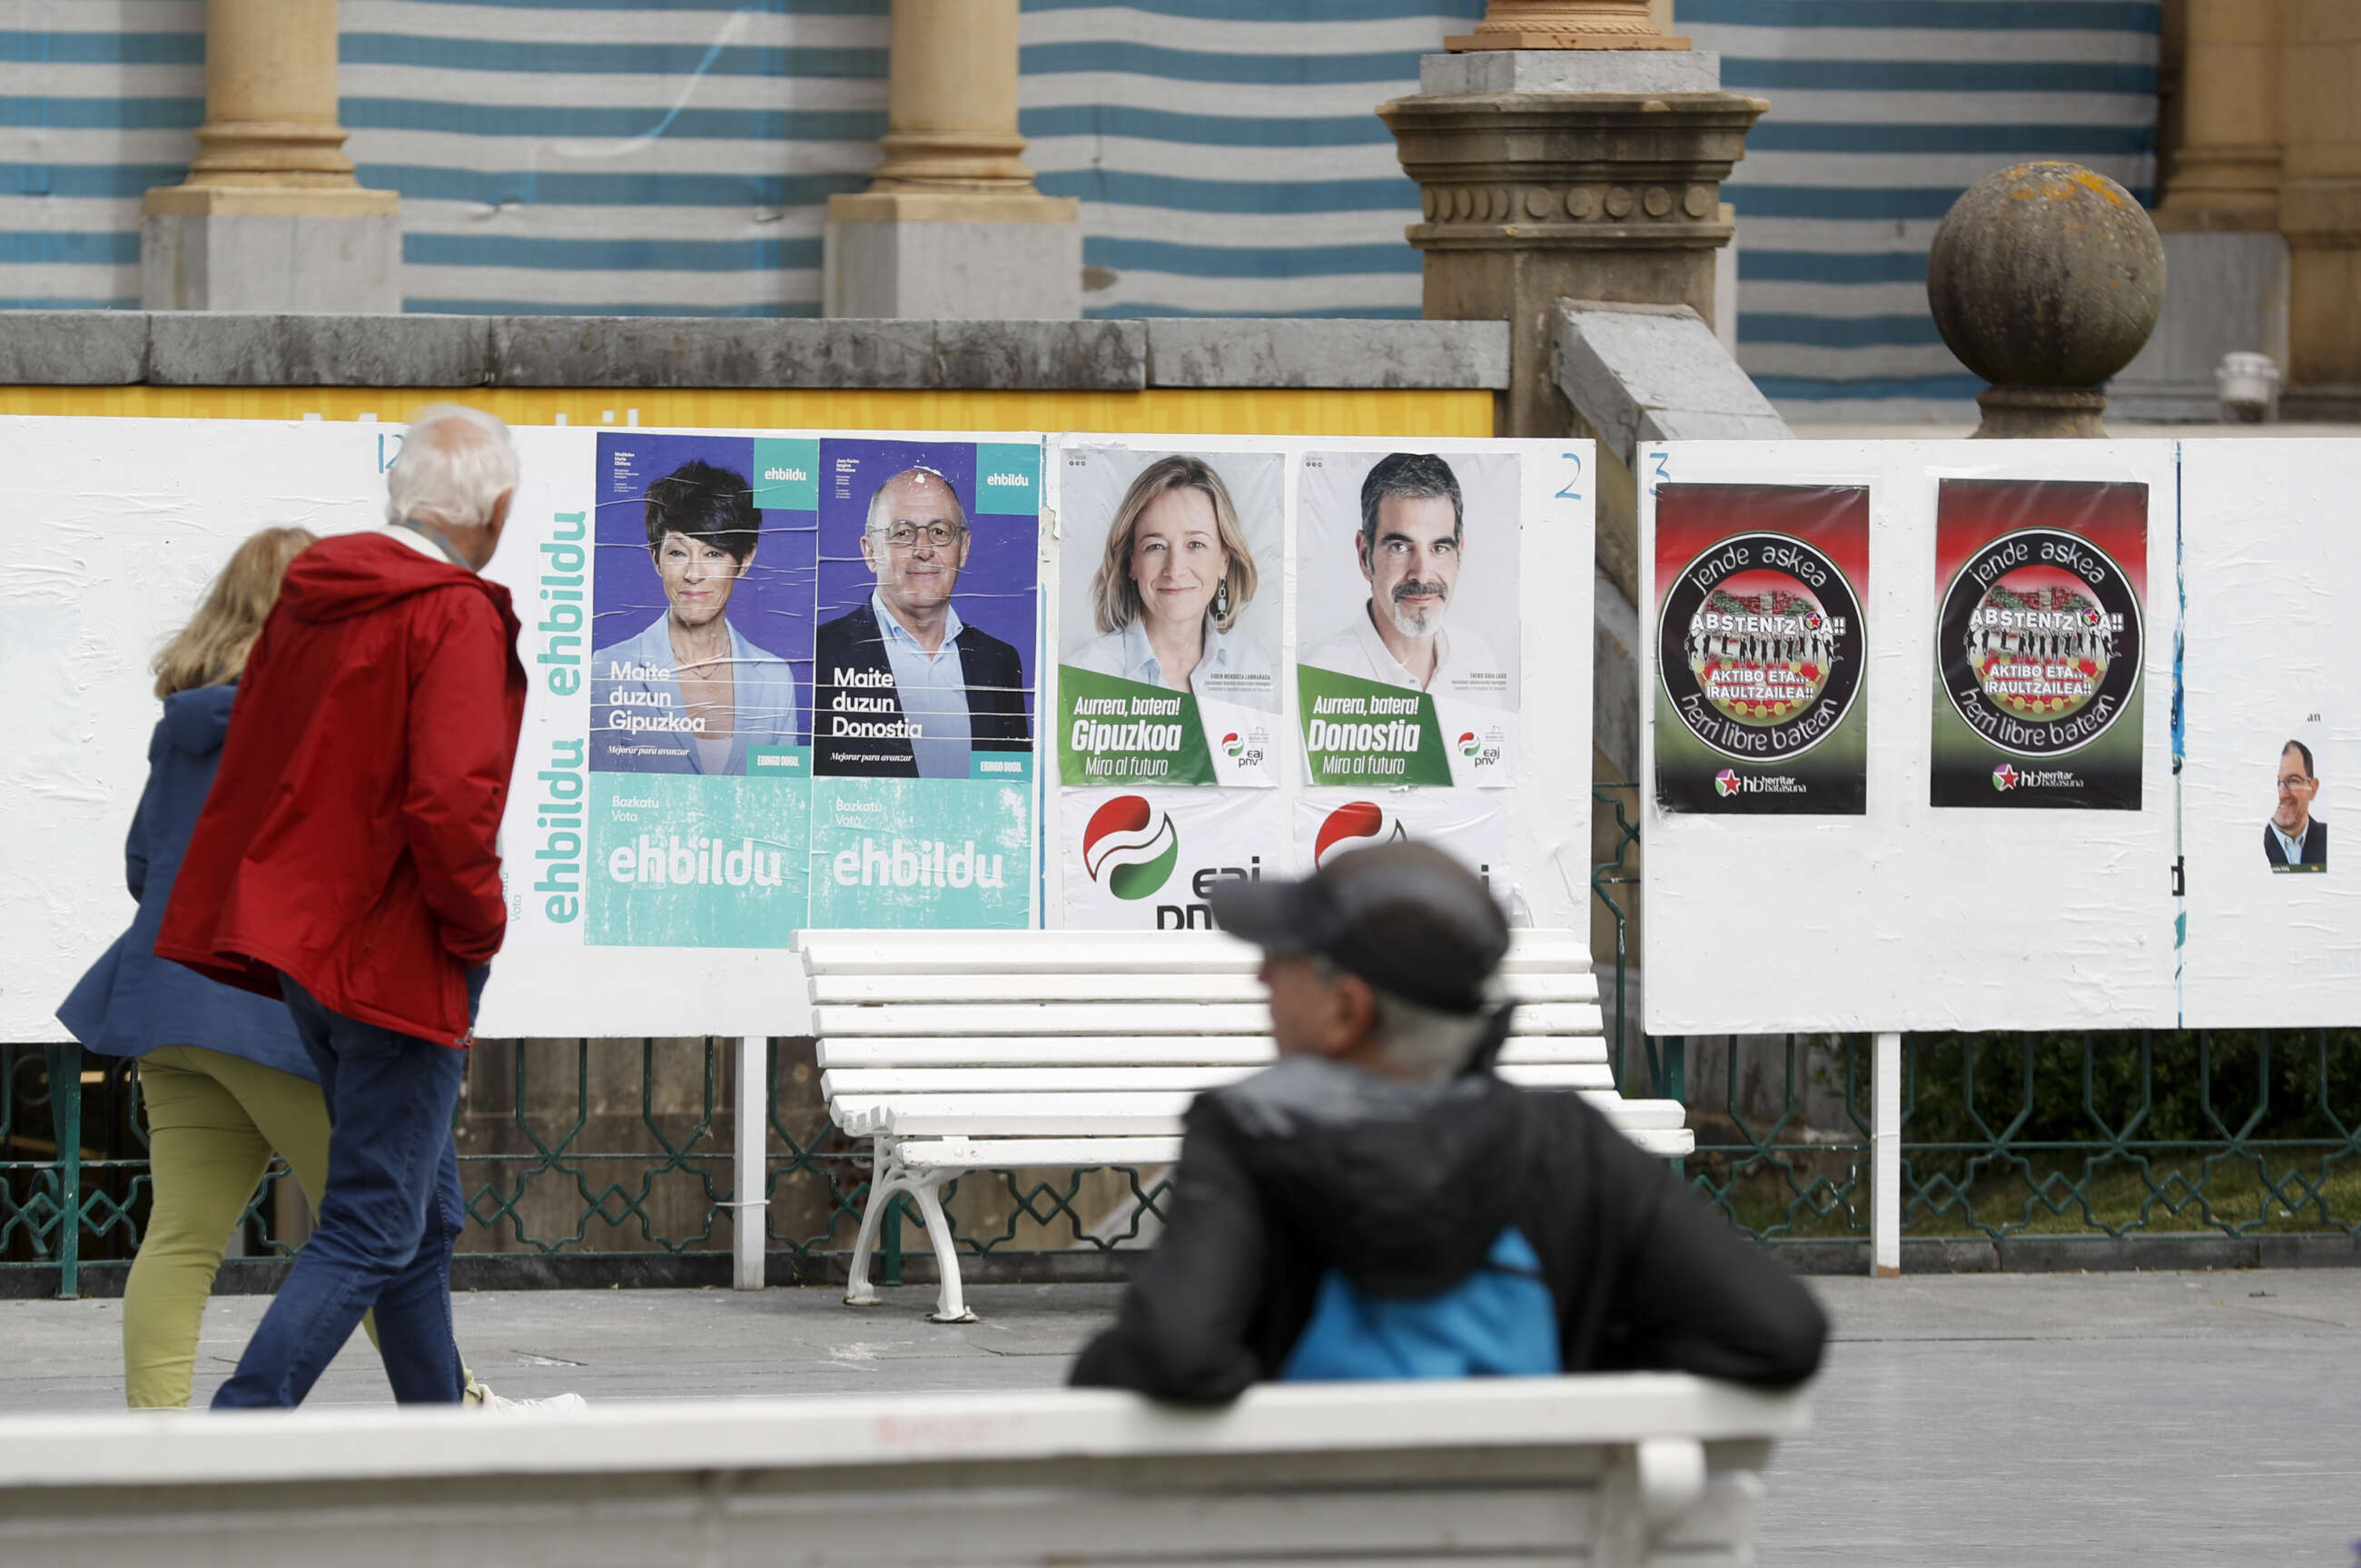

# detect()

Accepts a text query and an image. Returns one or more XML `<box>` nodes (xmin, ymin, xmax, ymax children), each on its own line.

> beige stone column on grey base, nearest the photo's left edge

<box><xmin>139</xmin><ymin>0</ymin><xmax>401</xmax><ymax>311</ymax></box>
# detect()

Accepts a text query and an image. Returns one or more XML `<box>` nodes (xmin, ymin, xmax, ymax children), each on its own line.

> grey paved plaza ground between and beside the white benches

<box><xmin>0</xmin><ymin>1268</ymin><xmax>2361</xmax><ymax>1568</ymax></box>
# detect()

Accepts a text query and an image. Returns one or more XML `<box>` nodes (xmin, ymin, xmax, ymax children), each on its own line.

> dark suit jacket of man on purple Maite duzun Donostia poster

<box><xmin>812</xmin><ymin>600</ymin><xmax>1032</xmax><ymax>779</ymax></box>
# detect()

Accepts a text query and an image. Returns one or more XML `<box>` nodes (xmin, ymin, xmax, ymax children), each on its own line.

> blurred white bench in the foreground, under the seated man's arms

<box><xmin>0</xmin><ymin>1375</ymin><xmax>1806</xmax><ymax>1568</ymax></box>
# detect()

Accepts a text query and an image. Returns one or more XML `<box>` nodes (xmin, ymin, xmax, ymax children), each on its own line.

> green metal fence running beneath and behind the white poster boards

<box><xmin>0</xmin><ymin>786</ymin><xmax>2361</xmax><ymax>1297</ymax></box>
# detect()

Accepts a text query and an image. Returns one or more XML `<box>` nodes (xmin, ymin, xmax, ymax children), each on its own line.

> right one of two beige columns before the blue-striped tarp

<box><xmin>824</xmin><ymin>0</ymin><xmax>1082</xmax><ymax>319</ymax></box>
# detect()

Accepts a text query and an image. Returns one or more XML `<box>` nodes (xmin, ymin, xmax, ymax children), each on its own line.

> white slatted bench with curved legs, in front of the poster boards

<box><xmin>795</xmin><ymin>931</ymin><xmax>1695</xmax><ymax>1323</ymax></box>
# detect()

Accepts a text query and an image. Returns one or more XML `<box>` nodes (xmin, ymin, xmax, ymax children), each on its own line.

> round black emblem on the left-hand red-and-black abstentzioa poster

<box><xmin>1657</xmin><ymin>534</ymin><xmax>1861</xmax><ymax>764</ymax></box>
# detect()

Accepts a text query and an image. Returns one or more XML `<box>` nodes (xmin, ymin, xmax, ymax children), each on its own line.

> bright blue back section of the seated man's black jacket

<box><xmin>1279</xmin><ymin>1226</ymin><xmax>1561</xmax><ymax>1384</ymax></box>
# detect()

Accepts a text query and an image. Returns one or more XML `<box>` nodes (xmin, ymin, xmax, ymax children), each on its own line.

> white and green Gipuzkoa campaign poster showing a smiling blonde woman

<box><xmin>1055</xmin><ymin>447</ymin><xmax>1287</xmax><ymax>789</ymax></box>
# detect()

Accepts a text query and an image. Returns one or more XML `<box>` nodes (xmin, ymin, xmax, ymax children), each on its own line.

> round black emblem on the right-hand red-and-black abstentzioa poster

<box><xmin>1936</xmin><ymin>529</ymin><xmax>2141</xmax><ymax>760</ymax></box>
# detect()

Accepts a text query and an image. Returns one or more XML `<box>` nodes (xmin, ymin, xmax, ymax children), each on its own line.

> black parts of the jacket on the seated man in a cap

<box><xmin>1074</xmin><ymin>1056</ymin><xmax>1827</xmax><ymax>1403</ymax></box>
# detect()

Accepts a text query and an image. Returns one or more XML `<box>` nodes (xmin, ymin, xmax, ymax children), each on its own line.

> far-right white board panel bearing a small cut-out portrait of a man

<box><xmin>2179</xmin><ymin>439</ymin><xmax>2361</xmax><ymax>1027</ymax></box>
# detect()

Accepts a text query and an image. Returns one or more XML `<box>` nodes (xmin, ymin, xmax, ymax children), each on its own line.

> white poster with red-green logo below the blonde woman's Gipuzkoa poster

<box><xmin>1060</xmin><ymin>789</ymin><xmax>1287</xmax><ymax>931</ymax></box>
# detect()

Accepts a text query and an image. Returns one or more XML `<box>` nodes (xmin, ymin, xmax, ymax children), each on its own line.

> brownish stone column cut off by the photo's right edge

<box><xmin>2276</xmin><ymin>0</ymin><xmax>2361</xmax><ymax>403</ymax></box>
